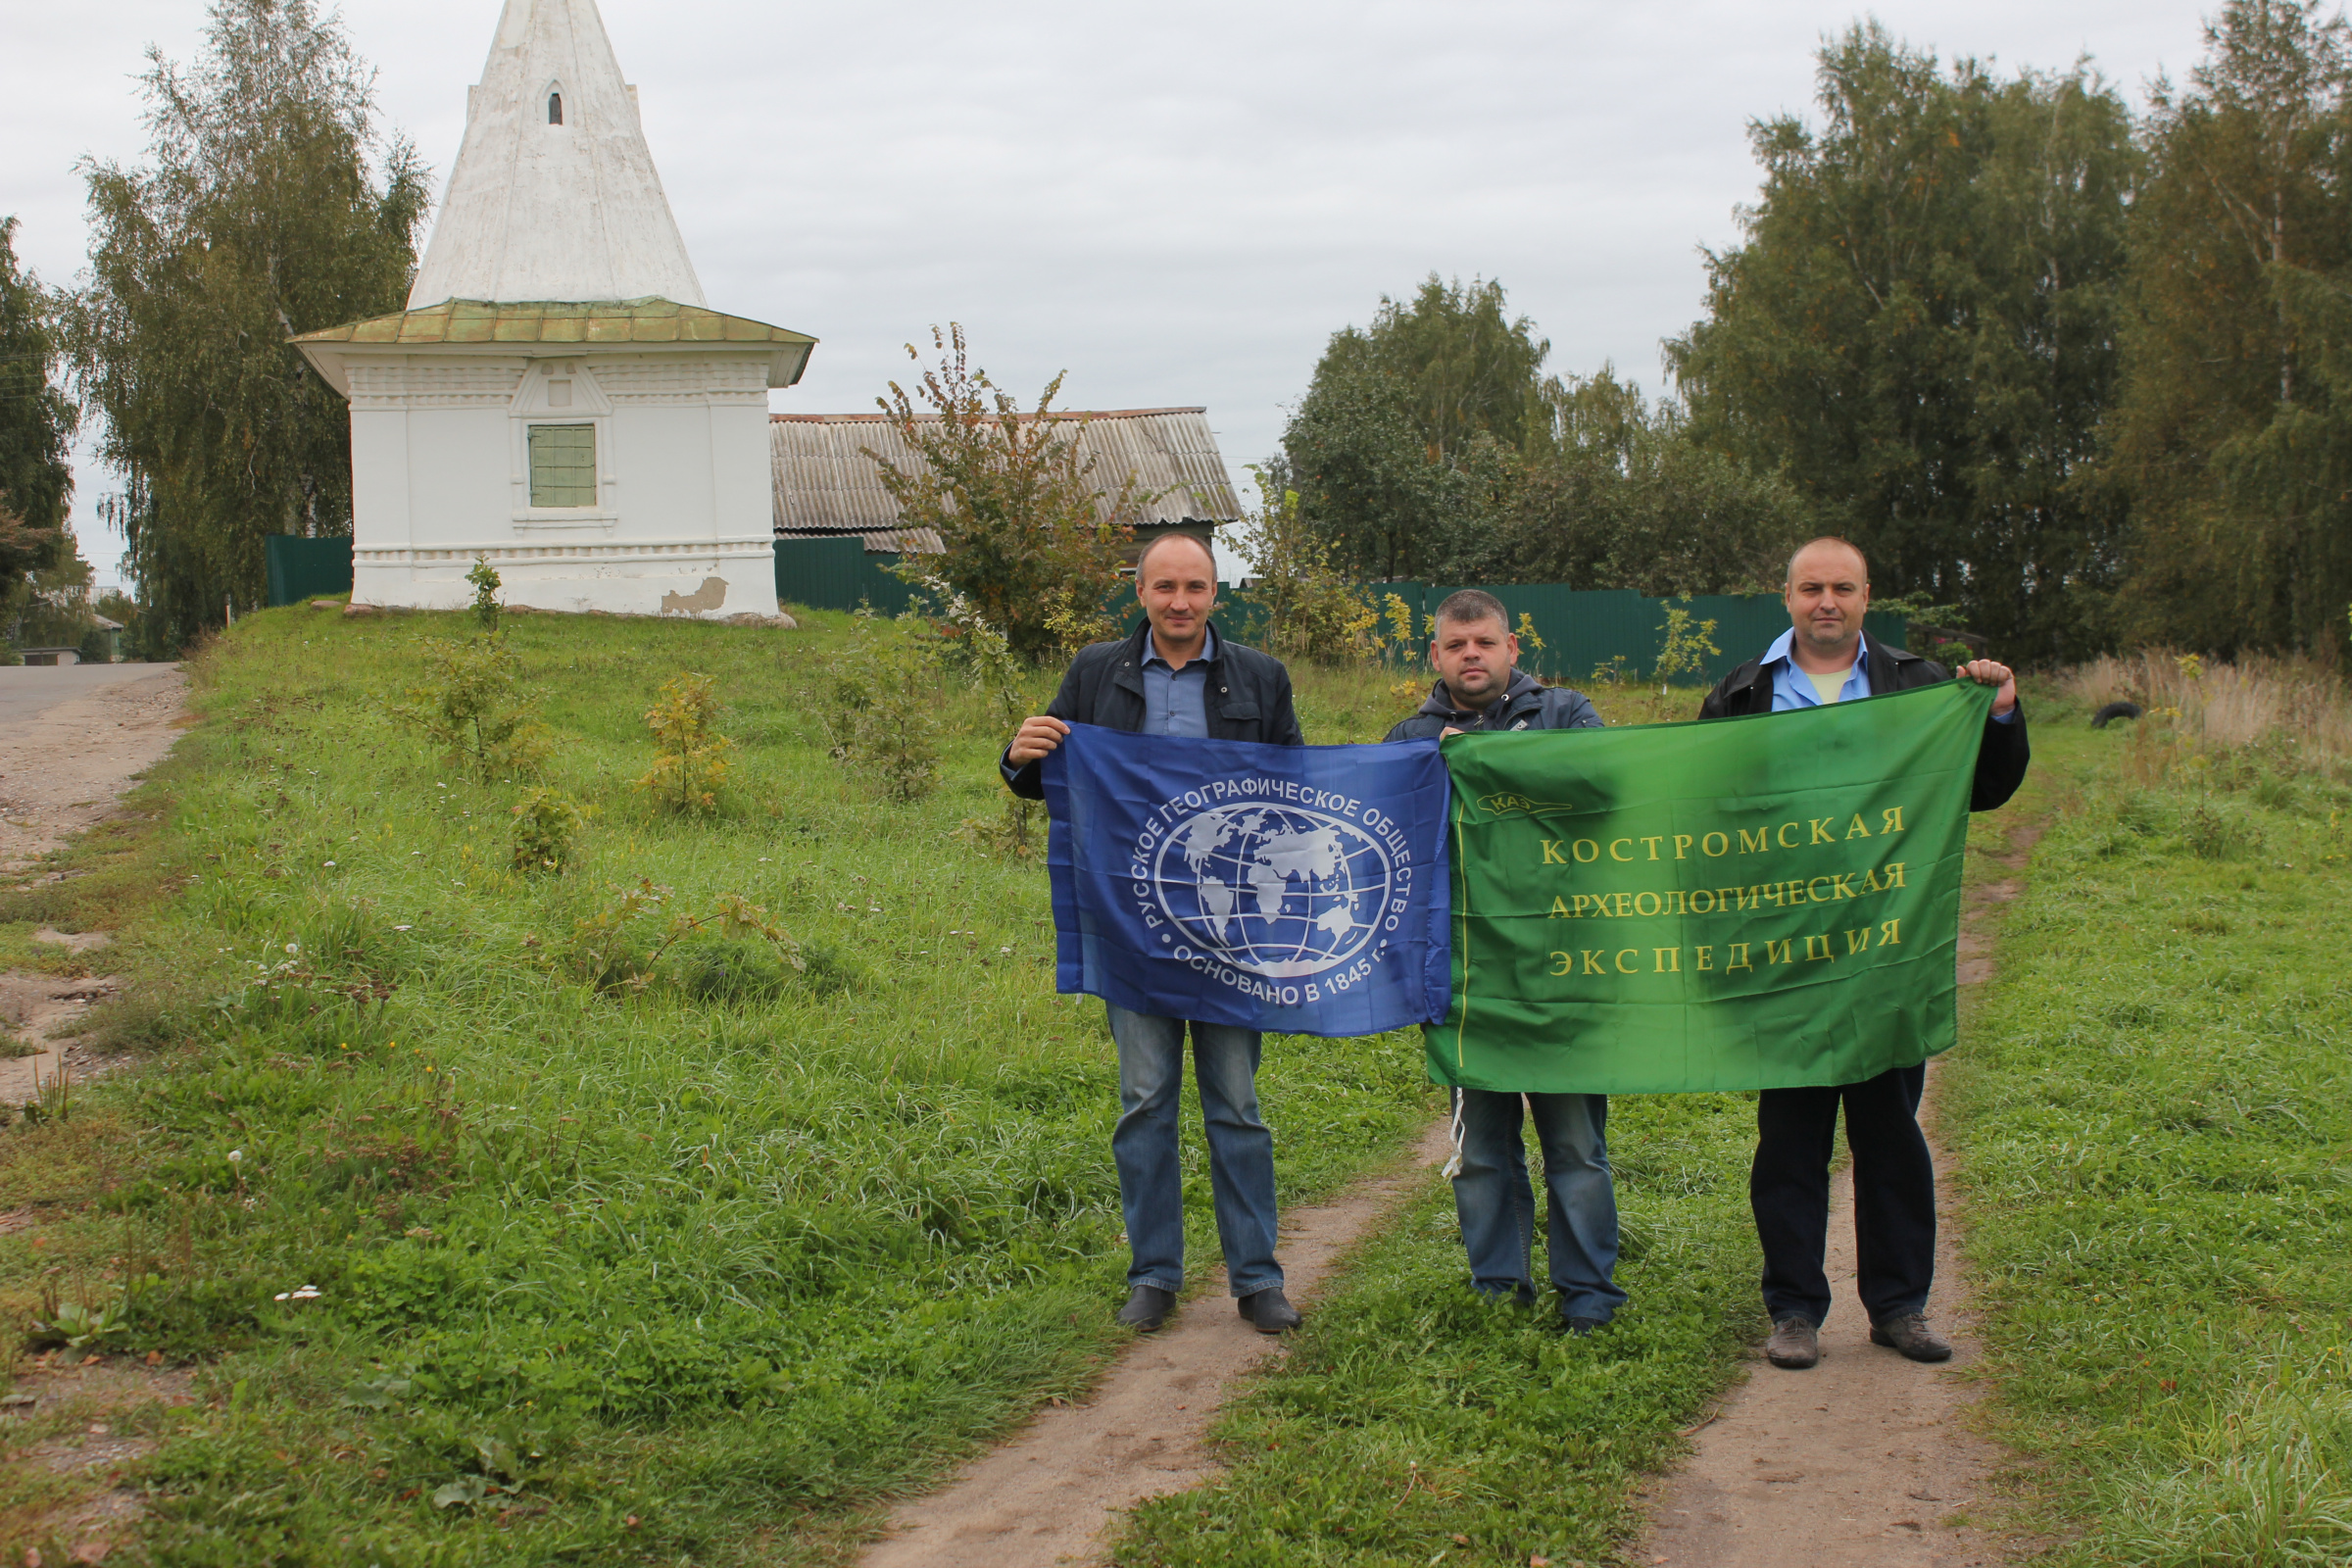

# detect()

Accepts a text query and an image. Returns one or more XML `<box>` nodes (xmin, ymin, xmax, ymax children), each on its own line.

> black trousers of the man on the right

<box><xmin>1747</xmin><ymin>1062</ymin><xmax>1936</xmax><ymax>1326</ymax></box>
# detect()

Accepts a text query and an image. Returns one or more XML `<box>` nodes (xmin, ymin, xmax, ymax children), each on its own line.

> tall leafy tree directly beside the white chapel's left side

<box><xmin>69</xmin><ymin>0</ymin><xmax>428</xmax><ymax>651</ymax></box>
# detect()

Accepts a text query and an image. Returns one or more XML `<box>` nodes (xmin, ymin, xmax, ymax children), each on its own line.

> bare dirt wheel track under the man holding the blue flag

<box><xmin>860</xmin><ymin>1124</ymin><xmax>1448</xmax><ymax>1568</ymax></box>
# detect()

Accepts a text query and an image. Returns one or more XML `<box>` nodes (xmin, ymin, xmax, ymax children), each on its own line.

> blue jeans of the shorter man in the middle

<box><xmin>1453</xmin><ymin>1089</ymin><xmax>1625</xmax><ymax>1321</ymax></box>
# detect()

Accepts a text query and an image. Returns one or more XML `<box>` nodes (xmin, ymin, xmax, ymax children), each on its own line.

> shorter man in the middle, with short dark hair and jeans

<box><xmin>1388</xmin><ymin>588</ymin><xmax>1625</xmax><ymax>1333</ymax></box>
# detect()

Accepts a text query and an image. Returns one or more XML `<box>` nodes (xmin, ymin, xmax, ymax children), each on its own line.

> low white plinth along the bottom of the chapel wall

<box><xmin>351</xmin><ymin>538</ymin><xmax>776</xmax><ymax>620</ymax></box>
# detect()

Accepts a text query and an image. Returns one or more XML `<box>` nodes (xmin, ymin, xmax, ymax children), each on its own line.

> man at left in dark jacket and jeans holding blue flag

<box><xmin>1000</xmin><ymin>534</ymin><xmax>1305</xmax><ymax>1333</ymax></box>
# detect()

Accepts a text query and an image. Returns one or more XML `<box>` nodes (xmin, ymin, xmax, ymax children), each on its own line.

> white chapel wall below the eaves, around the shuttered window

<box><xmin>348</xmin><ymin>343</ymin><xmax>776</xmax><ymax>618</ymax></box>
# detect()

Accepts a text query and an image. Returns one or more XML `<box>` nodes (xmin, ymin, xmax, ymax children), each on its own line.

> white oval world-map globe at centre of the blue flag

<box><xmin>1152</xmin><ymin>804</ymin><xmax>1395</xmax><ymax>980</ymax></box>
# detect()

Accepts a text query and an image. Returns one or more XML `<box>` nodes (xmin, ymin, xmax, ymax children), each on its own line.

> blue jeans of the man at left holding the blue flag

<box><xmin>1110</xmin><ymin>1006</ymin><xmax>1282</xmax><ymax>1296</ymax></box>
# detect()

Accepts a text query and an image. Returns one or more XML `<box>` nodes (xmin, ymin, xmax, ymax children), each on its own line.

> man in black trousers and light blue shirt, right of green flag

<box><xmin>1698</xmin><ymin>538</ymin><xmax>2028</xmax><ymax>1368</ymax></box>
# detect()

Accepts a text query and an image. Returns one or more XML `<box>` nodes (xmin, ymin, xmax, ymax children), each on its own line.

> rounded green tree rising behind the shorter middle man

<box><xmin>1282</xmin><ymin>272</ymin><xmax>1550</xmax><ymax>581</ymax></box>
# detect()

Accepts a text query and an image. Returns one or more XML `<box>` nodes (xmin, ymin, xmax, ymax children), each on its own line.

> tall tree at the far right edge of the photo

<box><xmin>2112</xmin><ymin>0</ymin><xmax>2352</xmax><ymax>661</ymax></box>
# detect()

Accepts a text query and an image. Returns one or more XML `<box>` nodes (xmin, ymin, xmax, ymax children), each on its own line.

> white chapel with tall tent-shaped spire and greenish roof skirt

<box><xmin>294</xmin><ymin>0</ymin><xmax>816</xmax><ymax>618</ymax></box>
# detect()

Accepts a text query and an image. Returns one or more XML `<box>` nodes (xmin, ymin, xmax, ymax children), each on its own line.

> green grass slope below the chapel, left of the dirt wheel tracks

<box><xmin>0</xmin><ymin>607</ymin><xmax>1435</xmax><ymax>1566</ymax></box>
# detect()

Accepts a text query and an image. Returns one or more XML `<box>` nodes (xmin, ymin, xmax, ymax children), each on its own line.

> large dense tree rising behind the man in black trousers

<box><xmin>1668</xmin><ymin>24</ymin><xmax>2138</xmax><ymax>656</ymax></box>
